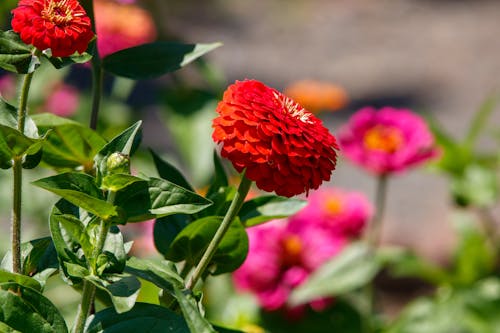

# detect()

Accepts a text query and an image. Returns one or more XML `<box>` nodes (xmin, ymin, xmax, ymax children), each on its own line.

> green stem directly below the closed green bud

<box><xmin>73</xmin><ymin>191</ymin><xmax>116</xmax><ymax>333</ymax></box>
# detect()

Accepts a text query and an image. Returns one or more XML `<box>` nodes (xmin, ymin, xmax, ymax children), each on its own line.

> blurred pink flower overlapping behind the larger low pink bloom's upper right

<box><xmin>290</xmin><ymin>188</ymin><xmax>373</xmax><ymax>238</ymax></box>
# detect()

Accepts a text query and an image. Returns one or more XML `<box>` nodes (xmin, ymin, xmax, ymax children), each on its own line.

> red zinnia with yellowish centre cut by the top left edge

<box><xmin>12</xmin><ymin>0</ymin><xmax>94</xmax><ymax>57</ymax></box>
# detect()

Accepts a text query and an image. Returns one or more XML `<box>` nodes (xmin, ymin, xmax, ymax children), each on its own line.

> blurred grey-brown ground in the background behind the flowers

<box><xmin>143</xmin><ymin>0</ymin><xmax>500</xmax><ymax>260</ymax></box>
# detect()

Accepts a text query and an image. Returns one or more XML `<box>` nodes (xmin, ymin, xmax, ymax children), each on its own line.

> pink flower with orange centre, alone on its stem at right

<box><xmin>339</xmin><ymin>107</ymin><xmax>438</xmax><ymax>175</ymax></box>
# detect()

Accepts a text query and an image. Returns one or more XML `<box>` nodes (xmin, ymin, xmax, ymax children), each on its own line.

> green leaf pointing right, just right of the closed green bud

<box><xmin>115</xmin><ymin>178</ymin><xmax>212</xmax><ymax>222</ymax></box>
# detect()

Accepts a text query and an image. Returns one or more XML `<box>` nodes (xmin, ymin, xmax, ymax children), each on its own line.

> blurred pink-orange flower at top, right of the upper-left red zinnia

<box><xmin>94</xmin><ymin>0</ymin><xmax>156</xmax><ymax>57</ymax></box>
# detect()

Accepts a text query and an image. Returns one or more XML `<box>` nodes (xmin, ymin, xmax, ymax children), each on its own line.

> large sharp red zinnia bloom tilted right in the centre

<box><xmin>212</xmin><ymin>80</ymin><xmax>338</xmax><ymax>197</ymax></box>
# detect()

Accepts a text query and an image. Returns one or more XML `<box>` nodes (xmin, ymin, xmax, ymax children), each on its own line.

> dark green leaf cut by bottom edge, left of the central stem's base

<box><xmin>85</xmin><ymin>303</ymin><xmax>191</xmax><ymax>333</ymax></box>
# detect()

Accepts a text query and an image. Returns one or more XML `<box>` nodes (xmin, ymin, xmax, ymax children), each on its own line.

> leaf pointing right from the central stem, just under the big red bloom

<box><xmin>238</xmin><ymin>195</ymin><xmax>307</xmax><ymax>227</ymax></box>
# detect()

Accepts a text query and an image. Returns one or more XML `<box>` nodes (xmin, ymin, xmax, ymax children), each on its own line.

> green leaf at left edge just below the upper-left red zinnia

<box><xmin>0</xmin><ymin>30</ymin><xmax>40</xmax><ymax>74</ymax></box>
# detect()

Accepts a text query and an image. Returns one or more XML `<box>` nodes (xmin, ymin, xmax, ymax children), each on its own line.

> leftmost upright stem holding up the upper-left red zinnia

<box><xmin>11</xmin><ymin>72</ymin><xmax>34</xmax><ymax>273</ymax></box>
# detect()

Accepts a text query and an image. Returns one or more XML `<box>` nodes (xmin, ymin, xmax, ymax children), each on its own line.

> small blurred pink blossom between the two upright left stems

<box><xmin>44</xmin><ymin>83</ymin><xmax>80</xmax><ymax>117</ymax></box>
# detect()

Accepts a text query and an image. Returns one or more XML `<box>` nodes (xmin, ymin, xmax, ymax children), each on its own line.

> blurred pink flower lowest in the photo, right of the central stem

<box><xmin>234</xmin><ymin>220</ymin><xmax>346</xmax><ymax>315</ymax></box>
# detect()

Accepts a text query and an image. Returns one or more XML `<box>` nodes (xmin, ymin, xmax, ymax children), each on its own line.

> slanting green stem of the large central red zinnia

<box><xmin>186</xmin><ymin>172</ymin><xmax>252</xmax><ymax>290</ymax></box>
